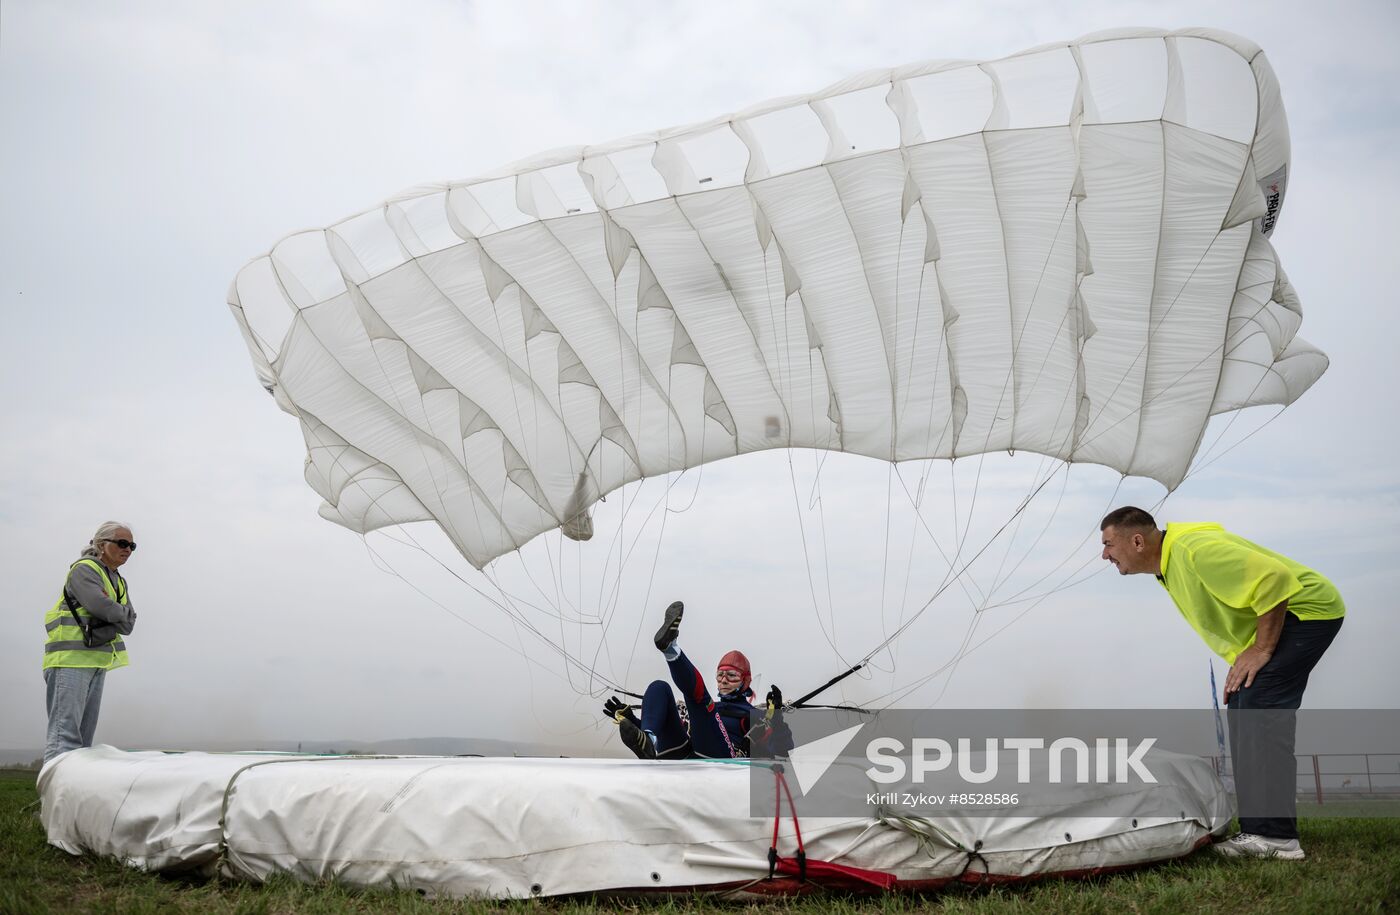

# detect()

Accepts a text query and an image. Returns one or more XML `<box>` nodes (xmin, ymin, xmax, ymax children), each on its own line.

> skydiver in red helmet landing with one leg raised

<box><xmin>603</xmin><ymin>600</ymin><xmax>792</xmax><ymax>760</ymax></box>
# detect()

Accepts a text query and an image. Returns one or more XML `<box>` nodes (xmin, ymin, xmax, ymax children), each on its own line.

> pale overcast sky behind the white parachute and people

<box><xmin>0</xmin><ymin>0</ymin><xmax>1400</xmax><ymax>753</ymax></box>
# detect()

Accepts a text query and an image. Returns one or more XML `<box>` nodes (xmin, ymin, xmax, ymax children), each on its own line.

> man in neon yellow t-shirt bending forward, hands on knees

<box><xmin>1099</xmin><ymin>505</ymin><xmax>1347</xmax><ymax>859</ymax></box>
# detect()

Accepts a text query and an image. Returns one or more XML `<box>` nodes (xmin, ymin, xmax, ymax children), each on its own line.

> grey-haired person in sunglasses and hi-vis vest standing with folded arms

<box><xmin>43</xmin><ymin>520</ymin><xmax>136</xmax><ymax>763</ymax></box>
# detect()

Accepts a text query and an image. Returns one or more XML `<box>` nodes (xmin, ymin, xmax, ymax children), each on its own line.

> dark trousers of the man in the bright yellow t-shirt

<box><xmin>1226</xmin><ymin>611</ymin><xmax>1341</xmax><ymax>839</ymax></box>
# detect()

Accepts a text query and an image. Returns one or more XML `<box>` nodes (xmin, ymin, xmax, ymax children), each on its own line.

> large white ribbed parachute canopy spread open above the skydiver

<box><xmin>228</xmin><ymin>29</ymin><xmax>1327</xmax><ymax>568</ymax></box>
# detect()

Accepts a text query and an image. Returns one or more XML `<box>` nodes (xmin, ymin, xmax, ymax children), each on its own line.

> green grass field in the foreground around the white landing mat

<box><xmin>0</xmin><ymin>772</ymin><xmax>1400</xmax><ymax>915</ymax></box>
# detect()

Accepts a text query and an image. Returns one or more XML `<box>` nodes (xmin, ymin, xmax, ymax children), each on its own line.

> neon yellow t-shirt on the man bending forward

<box><xmin>1158</xmin><ymin>523</ymin><xmax>1347</xmax><ymax>665</ymax></box>
